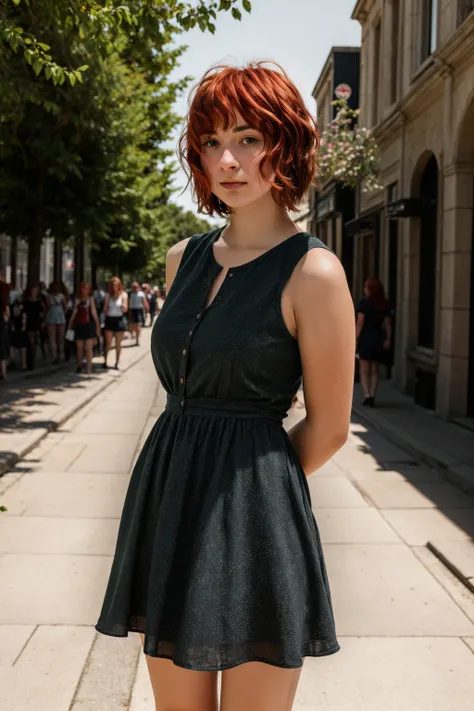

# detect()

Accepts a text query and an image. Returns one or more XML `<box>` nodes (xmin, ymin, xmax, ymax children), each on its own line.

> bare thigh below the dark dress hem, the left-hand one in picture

<box><xmin>140</xmin><ymin>634</ymin><xmax>218</xmax><ymax>711</ymax></box>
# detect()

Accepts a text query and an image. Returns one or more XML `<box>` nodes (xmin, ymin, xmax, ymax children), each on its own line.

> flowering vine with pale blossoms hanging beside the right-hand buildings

<box><xmin>319</xmin><ymin>99</ymin><xmax>382</xmax><ymax>193</ymax></box>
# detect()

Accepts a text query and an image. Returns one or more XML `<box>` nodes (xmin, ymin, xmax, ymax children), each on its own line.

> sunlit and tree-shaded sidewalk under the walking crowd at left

<box><xmin>0</xmin><ymin>329</ymin><xmax>151</xmax><ymax>476</ymax></box>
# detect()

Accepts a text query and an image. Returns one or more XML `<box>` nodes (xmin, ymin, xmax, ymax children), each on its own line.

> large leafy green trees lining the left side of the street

<box><xmin>0</xmin><ymin>0</ymin><xmax>251</xmax><ymax>281</ymax></box>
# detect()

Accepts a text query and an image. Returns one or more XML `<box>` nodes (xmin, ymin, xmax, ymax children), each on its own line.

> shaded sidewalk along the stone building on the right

<box><xmin>352</xmin><ymin>380</ymin><xmax>474</xmax><ymax>493</ymax></box>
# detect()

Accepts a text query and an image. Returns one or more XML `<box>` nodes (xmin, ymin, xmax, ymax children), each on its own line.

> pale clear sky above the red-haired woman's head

<box><xmin>169</xmin><ymin>0</ymin><xmax>361</xmax><ymax>214</ymax></box>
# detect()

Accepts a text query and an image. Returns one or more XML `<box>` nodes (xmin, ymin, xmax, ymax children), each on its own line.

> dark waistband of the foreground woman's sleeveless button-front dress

<box><xmin>165</xmin><ymin>393</ymin><xmax>286</xmax><ymax>423</ymax></box>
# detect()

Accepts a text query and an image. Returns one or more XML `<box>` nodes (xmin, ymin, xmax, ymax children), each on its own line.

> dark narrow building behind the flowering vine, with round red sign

<box><xmin>309</xmin><ymin>47</ymin><xmax>360</xmax><ymax>294</ymax></box>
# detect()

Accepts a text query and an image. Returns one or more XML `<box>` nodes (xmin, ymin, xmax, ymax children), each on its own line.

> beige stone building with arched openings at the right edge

<box><xmin>348</xmin><ymin>0</ymin><xmax>474</xmax><ymax>418</ymax></box>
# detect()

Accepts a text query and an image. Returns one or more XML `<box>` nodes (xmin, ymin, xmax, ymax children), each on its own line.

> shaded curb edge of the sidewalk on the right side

<box><xmin>352</xmin><ymin>405</ymin><xmax>474</xmax><ymax>494</ymax></box>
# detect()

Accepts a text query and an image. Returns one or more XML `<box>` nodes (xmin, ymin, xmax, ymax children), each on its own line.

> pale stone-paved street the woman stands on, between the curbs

<box><xmin>0</xmin><ymin>344</ymin><xmax>474</xmax><ymax>711</ymax></box>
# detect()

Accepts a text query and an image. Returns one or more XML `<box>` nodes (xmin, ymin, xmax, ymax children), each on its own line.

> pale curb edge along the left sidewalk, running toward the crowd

<box><xmin>0</xmin><ymin>349</ymin><xmax>149</xmax><ymax>478</ymax></box>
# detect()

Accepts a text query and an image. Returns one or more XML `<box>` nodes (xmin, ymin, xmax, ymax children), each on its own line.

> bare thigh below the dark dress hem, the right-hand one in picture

<box><xmin>220</xmin><ymin>662</ymin><xmax>302</xmax><ymax>711</ymax></box>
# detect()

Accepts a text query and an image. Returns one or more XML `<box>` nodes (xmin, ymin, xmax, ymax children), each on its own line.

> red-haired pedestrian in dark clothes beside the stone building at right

<box><xmin>356</xmin><ymin>277</ymin><xmax>392</xmax><ymax>407</ymax></box>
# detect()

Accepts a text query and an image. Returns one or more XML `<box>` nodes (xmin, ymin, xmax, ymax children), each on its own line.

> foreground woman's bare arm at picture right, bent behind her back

<box><xmin>288</xmin><ymin>249</ymin><xmax>355</xmax><ymax>476</ymax></box>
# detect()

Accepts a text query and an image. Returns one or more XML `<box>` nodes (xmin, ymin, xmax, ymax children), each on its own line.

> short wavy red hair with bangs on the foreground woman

<box><xmin>178</xmin><ymin>61</ymin><xmax>320</xmax><ymax>217</ymax></box>
